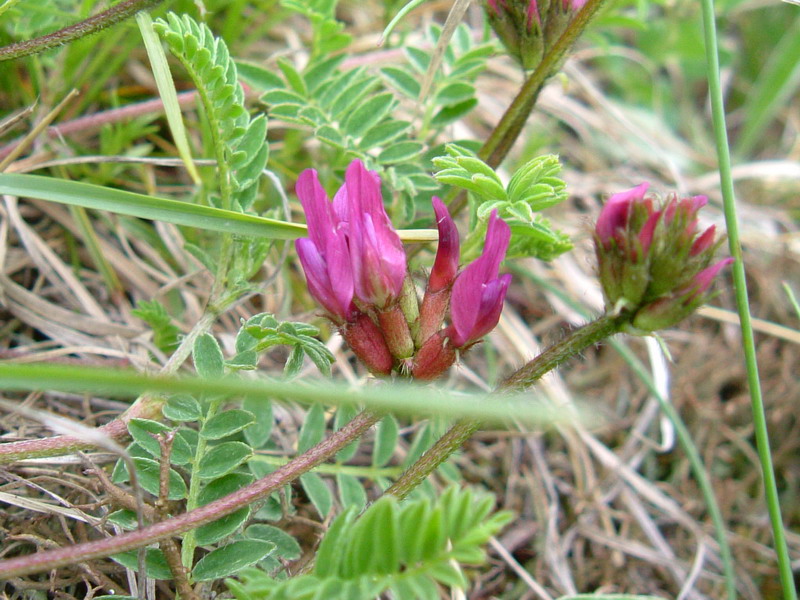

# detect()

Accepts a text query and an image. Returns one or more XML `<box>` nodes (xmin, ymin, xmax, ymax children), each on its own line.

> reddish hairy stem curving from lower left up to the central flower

<box><xmin>0</xmin><ymin>411</ymin><xmax>382</xmax><ymax>580</ymax></box>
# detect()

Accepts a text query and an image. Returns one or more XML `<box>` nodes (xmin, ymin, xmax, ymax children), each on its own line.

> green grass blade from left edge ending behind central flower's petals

<box><xmin>0</xmin><ymin>173</ymin><xmax>306</xmax><ymax>240</ymax></box>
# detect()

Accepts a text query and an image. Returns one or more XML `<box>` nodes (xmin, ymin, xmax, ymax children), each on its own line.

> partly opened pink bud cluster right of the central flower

<box><xmin>594</xmin><ymin>183</ymin><xmax>733</xmax><ymax>332</ymax></box>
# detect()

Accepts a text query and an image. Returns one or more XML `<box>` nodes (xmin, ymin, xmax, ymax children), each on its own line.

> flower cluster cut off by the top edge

<box><xmin>486</xmin><ymin>0</ymin><xmax>586</xmax><ymax>70</ymax></box>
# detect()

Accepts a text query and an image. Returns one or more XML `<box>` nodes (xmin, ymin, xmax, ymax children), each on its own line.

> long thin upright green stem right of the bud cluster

<box><xmin>700</xmin><ymin>0</ymin><xmax>797</xmax><ymax>600</ymax></box>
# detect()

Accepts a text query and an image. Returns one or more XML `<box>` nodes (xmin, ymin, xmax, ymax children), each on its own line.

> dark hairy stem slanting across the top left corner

<box><xmin>0</xmin><ymin>0</ymin><xmax>161</xmax><ymax>62</ymax></box>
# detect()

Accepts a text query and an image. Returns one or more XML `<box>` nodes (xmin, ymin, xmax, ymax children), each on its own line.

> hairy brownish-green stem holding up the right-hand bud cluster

<box><xmin>386</xmin><ymin>315</ymin><xmax>622</xmax><ymax>498</ymax></box>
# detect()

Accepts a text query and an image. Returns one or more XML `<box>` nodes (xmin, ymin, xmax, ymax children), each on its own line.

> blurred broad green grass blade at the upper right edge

<box><xmin>734</xmin><ymin>15</ymin><xmax>800</xmax><ymax>156</ymax></box>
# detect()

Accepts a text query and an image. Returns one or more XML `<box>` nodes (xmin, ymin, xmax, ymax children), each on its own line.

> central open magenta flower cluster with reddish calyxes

<box><xmin>296</xmin><ymin>160</ymin><xmax>511</xmax><ymax>379</ymax></box>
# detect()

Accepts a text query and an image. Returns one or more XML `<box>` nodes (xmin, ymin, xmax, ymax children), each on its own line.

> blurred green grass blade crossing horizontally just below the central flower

<box><xmin>0</xmin><ymin>363</ymin><xmax>575</xmax><ymax>425</ymax></box>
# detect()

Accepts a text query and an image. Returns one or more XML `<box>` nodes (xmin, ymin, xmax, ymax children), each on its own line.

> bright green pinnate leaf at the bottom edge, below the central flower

<box><xmin>228</xmin><ymin>487</ymin><xmax>511</xmax><ymax>600</ymax></box>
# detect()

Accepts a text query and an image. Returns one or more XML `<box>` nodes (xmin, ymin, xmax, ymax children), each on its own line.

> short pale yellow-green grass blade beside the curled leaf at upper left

<box><xmin>136</xmin><ymin>11</ymin><xmax>200</xmax><ymax>184</ymax></box>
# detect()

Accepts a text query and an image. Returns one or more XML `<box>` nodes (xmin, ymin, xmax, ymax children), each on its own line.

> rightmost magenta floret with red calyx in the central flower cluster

<box><xmin>449</xmin><ymin>211</ymin><xmax>511</xmax><ymax>348</ymax></box>
